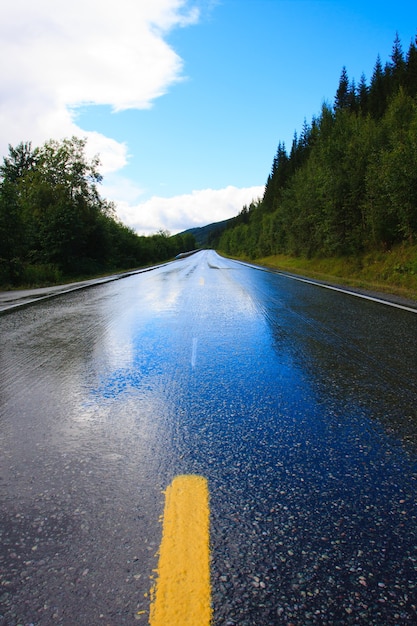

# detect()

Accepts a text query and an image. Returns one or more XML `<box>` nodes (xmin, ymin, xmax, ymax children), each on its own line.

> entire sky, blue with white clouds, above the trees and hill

<box><xmin>0</xmin><ymin>0</ymin><xmax>417</xmax><ymax>233</ymax></box>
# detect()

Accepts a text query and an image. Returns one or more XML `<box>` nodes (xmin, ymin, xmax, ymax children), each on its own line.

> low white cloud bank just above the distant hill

<box><xmin>117</xmin><ymin>186</ymin><xmax>264</xmax><ymax>235</ymax></box>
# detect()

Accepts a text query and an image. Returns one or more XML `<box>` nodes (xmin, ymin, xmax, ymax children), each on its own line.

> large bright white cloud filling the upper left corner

<box><xmin>0</xmin><ymin>0</ymin><xmax>198</xmax><ymax>168</ymax></box>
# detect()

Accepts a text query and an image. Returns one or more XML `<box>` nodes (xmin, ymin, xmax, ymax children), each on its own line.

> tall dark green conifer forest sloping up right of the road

<box><xmin>211</xmin><ymin>35</ymin><xmax>417</xmax><ymax>258</ymax></box>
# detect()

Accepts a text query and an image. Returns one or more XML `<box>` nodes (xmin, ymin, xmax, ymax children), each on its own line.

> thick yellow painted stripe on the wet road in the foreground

<box><xmin>149</xmin><ymin>475</ymin><xmax>211</xmax><ymax>626</ymax></box>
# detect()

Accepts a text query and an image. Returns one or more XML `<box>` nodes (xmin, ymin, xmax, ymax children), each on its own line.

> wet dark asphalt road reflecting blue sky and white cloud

<box><xmin>0</xmin><ymin>251</ymin><xmax>417</xmax><ymax>626</ymax></box>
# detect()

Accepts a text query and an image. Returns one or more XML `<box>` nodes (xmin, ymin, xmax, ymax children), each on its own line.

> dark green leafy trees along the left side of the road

<box><xmin>0</xmin><ymin>137</ymin><xmax>195</xmax><ymax>286</ymax></box>
